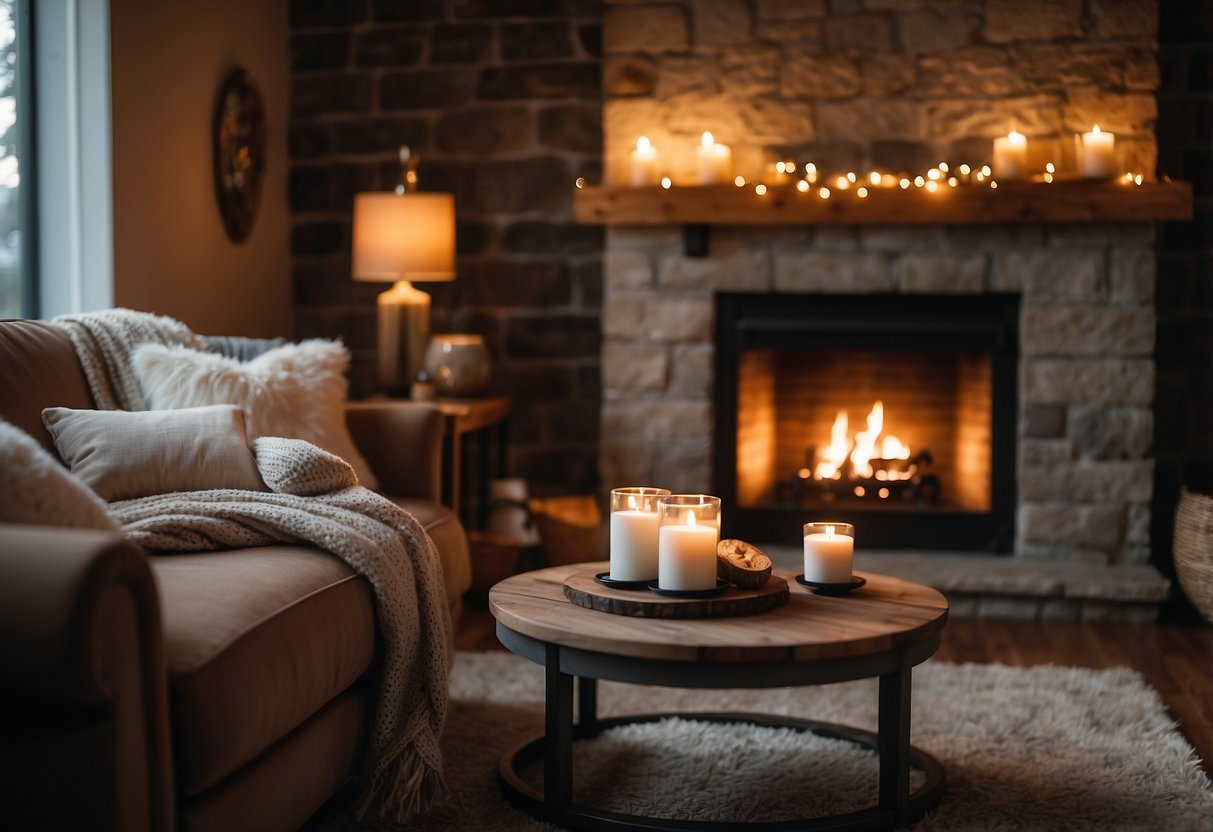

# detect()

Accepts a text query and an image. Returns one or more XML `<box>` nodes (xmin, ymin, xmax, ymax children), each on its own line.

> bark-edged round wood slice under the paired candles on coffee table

<box><xmin>564</xmin><ymin>569</ymin><xmax>788</xmax><ymax>619</ymax></box>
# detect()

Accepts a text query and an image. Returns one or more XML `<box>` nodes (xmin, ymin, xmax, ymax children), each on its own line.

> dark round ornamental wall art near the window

<box><xmin>213</xmin><ymin>69</ymin><xmax>266</xmax><ymax>243</ymax></box>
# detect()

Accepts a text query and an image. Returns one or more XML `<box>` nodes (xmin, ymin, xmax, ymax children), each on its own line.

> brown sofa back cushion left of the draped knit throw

<box><xmin>0</xmin><ymin>320</ymin><xmax>93</xmax><ymax>454</ymax></box>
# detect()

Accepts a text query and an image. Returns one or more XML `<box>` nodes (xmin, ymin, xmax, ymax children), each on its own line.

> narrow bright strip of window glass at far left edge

<box><xmin>0</xmin><ymin>0</ymin><xmax>21</xmax><ymax>318</ymax></box>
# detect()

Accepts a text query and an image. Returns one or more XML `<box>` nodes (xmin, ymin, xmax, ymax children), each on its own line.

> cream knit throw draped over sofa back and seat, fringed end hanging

<box><xmin>56</xmin><ymin>310</ymin><xmax>451</xmax><ymax>822</ymax></box>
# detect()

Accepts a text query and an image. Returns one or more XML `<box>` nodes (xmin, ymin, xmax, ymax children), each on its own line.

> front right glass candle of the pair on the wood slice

<box><xmin>657</xmin><ymin>494</ymin><xmax>721</xmax><ymax>589</ymax></box>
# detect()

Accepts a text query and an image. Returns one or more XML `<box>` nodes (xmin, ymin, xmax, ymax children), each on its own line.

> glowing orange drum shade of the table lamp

<box><xmin>351</xmin><ymin>192</ymin><xmax>455</xmax><ymax>283</ymax></box>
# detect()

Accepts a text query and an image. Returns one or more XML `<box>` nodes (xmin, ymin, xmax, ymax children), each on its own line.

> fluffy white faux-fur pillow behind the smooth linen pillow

<box><xmin>131</xmin><ymin>338</ymin><xmax>377</xmax><ymax>489</ymax></box>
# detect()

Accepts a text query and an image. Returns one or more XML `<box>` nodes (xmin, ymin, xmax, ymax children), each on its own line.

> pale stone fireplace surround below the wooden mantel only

<box><xmin>600</xmin><ymin>223</ymin><xmax>1155</xmax><ymax>565</ymax></box>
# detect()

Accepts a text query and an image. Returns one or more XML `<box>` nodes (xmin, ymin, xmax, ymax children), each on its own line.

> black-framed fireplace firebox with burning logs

<box><xmin>714</xmin><ymin>292</ymin><xmax>1019</xmax><ymax>552</ymax></box>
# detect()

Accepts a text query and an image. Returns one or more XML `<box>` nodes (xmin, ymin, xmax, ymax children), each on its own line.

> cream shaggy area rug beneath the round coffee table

<box><xmin>306</xmin><ymin>653</ymin><xmax>1213</xmax><ymax>832</ymax></box>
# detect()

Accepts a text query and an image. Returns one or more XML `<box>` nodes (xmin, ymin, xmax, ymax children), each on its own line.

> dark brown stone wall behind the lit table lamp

<box><xmin>290</xmin><ymin>0</ymin><xmax>602</xmax><ymax>494</ymax></box>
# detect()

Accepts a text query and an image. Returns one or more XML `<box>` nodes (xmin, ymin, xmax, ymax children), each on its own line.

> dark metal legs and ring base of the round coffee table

<box><xmin>497</xmin><ymin>622</ymin><xmax>944</xmax><ymax>832</ymax></box>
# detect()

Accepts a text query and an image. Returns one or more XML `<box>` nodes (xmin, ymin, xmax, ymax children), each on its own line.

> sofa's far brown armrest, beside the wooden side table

<box><xmin>346</xmin><ymin>400</ymin><xmax>443</xmax><ymax>502</ymax></box>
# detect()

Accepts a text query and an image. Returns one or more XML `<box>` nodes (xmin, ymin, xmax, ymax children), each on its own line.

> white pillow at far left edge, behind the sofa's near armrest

<box><xmin>0</xmin><ymin>420</ymin><xmax>120</xmax><ymax>531</ymax></box>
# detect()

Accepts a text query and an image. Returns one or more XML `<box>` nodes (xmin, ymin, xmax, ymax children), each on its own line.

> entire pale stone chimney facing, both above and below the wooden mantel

<box><xmin>599</xmin><ymin>0</ymin><xmax>1158</xmax><ymax>597</ymax></box>
